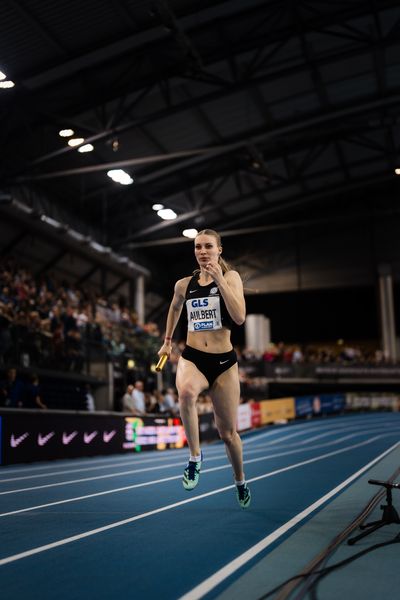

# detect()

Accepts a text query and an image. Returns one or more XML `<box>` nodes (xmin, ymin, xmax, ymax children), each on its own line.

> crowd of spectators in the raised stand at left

<box><xmin>0</xmin><ymin>259</ymin><xmax>159</xmax><ymax>373</ymax></box>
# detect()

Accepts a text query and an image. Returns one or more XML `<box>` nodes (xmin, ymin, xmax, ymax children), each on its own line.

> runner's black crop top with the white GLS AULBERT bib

<box><xmin>185</xmin><ymin>273</ymin><xmax>233</xmax><ymax>331</ymax></box>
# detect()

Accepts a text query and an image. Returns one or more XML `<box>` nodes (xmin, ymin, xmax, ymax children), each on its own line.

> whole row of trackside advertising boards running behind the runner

<box><xmin>0</xmin><ymin>392</ymin><xmax>400</xmax><ymax>465</ymax></box>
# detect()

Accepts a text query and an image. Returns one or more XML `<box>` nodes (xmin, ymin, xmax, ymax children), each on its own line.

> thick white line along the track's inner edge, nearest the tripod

<box><xmin>178</xmin><ymin>442</ymin><xmax>399</xmax><ymax>600</ymax></box>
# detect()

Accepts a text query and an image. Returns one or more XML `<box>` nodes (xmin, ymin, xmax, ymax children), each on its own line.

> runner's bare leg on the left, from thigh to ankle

<box><xmin>176</xmin><ymin>357</ymin><xmax>208</xmax><ymax>456</ymax></box>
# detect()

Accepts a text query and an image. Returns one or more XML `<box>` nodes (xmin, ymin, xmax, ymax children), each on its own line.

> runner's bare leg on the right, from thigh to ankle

<box><xmin>210</xmin><ymin>364</ymin><xmax>244</xmax><ymax>481</ymax></box>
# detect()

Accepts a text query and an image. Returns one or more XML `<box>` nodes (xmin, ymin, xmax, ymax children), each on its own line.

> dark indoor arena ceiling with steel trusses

<box><xmin>0</xmin><ymin>0</ymin><xmax>400</xmax><ymax>300</ymax></box>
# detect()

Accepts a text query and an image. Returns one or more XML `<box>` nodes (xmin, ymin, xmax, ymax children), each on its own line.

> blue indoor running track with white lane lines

<box><xmin>0</xmin><ymin>413</ymin><xmax>400</xmax><ymax>600</ymax></box>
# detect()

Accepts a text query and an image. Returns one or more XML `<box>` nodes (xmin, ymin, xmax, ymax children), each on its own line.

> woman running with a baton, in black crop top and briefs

<box><xmin>158</xmin><ymin>229</ymin><xmax>251</xmax><ymax>508</ymax></box>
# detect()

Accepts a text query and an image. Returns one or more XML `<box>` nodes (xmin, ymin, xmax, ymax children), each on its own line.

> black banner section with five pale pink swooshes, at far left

<box><xmin>1</xmin><ymin>410</ymin><xmax>123</xmax><ymax>464</ymax></box>
